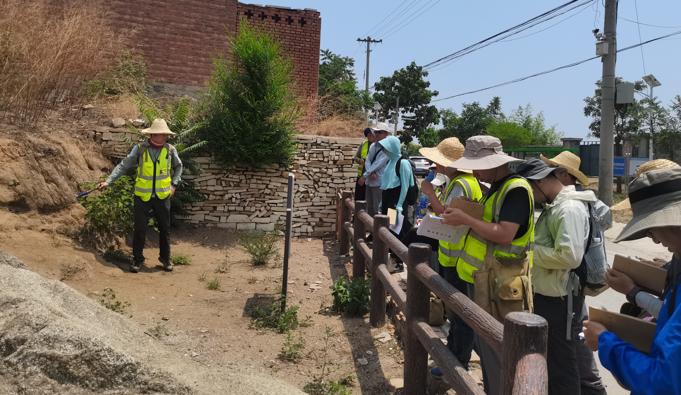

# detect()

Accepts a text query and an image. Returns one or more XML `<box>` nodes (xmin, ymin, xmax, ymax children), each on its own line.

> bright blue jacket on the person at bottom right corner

<box><xmin>598</xmin><ymin>263</ymin><xmax>681</xmax><ymax>395</ymax></box>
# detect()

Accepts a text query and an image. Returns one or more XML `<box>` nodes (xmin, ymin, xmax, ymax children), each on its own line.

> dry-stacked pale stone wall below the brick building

<box><xmin>95</xmin><ymin>127</ymin><xmax>363</xmax><ymax>236</ymax></box>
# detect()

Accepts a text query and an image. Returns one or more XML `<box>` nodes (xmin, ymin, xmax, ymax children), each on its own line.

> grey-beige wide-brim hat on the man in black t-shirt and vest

<box><xmin>451</xmin><ymin>136</ymin><xmax>519</xmax><ymax>170</ymax></box>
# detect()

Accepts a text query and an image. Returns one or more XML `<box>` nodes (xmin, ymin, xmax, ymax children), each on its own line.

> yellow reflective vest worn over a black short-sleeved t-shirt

<box><xmin>456</xmin><ymin>177</ymin><xmax>534</xmax><ymax>284</ymax></box>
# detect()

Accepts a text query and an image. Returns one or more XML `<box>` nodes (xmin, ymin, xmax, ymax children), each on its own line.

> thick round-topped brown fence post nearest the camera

<box><xmin>500</xmin><ymin>312</ymin><xmax>548</xmax><ymax>394</ymax></box>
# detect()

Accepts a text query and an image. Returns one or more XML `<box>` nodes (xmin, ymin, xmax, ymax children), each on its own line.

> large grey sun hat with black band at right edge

<box><xmin>615</xmin><ymin>167</ymin><xmax>681</xmax><ymax>243</ymax></box>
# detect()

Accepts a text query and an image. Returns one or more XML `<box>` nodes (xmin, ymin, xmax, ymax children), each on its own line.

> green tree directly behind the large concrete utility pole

<box><xmin>584</xmin><ymin>77</ymin><xmax>645</xmax><ymax>155</ymax></box>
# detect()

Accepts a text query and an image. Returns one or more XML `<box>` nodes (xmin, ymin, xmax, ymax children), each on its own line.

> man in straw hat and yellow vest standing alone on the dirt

<box><xmin>98</xmin><ymin>119</ymin><xmax>182</xmax><ymax>273</ymax></box>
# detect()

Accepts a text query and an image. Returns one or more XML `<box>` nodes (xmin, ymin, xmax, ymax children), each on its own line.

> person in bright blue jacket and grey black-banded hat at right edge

<box><xmin>584</xmin><ymin>168</ymin><xmax>681</xmax><ymax>394</ymax></box>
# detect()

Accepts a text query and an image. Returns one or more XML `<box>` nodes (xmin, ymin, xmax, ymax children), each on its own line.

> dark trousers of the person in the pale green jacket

<box><xmin>534</xmin><ymin>294</ymin><xmax>584</xmax><ymax>395</ymax></box>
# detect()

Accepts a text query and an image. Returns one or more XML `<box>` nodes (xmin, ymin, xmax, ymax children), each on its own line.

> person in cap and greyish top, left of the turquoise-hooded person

<box><xmin>362</xmin><ymin>122</ymin><xmax>390</xmax><ymax>217</ymax></box>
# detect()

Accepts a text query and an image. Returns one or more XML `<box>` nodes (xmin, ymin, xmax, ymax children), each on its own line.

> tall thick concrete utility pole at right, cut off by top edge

<box><xmin>598</xmin><ymin>0</ymin><xmax>617</xmax><ymax>206</ymax></box>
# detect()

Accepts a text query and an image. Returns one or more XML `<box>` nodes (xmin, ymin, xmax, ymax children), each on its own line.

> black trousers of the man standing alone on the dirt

<box><xmin>132</xmin><ymin>196</ymin><xmax>170</xmax><ymax>265</ymax></box>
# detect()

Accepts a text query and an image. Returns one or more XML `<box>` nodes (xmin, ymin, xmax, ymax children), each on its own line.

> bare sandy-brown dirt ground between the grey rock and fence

<box><xmin>0</xmin><ymin>208</ymin><xmax>403</xmax><ymax>394</ymax></box>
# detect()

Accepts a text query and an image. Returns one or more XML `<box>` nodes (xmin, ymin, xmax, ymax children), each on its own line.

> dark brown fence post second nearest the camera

<box><xmin>404</xmin><ymin>243</ymin><xmax>431</xmax><ymax>395</ymax></box>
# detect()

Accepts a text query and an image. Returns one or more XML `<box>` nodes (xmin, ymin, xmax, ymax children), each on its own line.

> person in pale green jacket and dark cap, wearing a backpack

<box><xmin>518</xmin><ymin>159</ymin><xmax>597</xmax><ymax>395</ymax></box>
